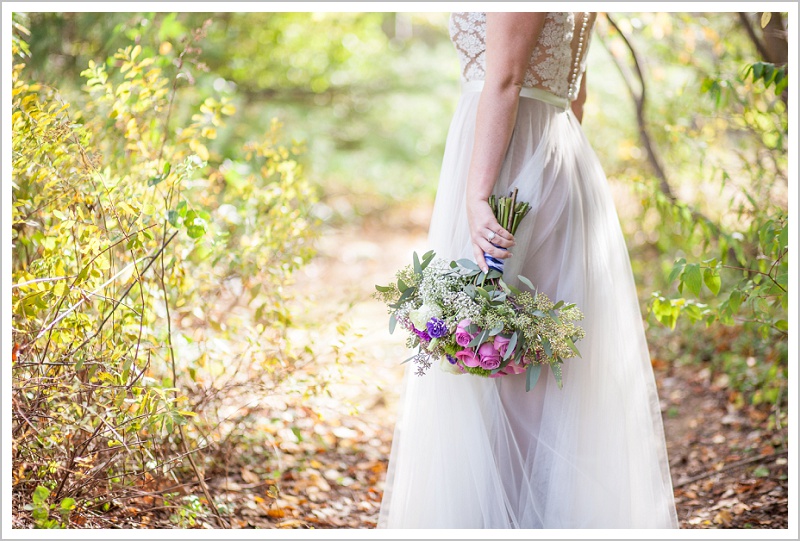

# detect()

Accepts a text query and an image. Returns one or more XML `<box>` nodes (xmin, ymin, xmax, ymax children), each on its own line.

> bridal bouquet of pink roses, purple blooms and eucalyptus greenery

<box><xmin>375</xmin><ymin>190</ymin><xmax>584</xmax><ymax>391</ymax></box>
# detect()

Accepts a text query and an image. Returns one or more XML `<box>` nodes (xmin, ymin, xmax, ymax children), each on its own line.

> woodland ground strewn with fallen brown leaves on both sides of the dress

<box><xmin>15</xmin><ymin>205</ymin><xmax>788</xmax><ymax>528</ymax></box>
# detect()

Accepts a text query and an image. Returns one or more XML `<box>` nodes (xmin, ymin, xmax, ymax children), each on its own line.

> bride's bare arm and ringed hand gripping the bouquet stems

<box><xmin>467</xmin><ymin>13</ymin><xmax>546</xmax><ymax>272</ymax></box>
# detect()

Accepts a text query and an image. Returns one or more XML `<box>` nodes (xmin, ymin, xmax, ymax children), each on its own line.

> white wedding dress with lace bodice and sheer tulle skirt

<box><xmin>378</xmin><ymin>13</ymin><xmax>677</xmax><ymax>528</ymax></box>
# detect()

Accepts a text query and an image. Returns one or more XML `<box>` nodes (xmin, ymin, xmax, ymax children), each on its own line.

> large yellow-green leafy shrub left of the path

<box><xmin>12</xmin><ymin>14</ymin><xmax>316</xmax><ymax>527</ymax></box>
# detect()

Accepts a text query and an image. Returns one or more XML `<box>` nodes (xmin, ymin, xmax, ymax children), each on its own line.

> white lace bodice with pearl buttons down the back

<box><xmin>450</xmin><ymin>12</ymin><xmax>595</xmax><ymax>101</ymax></box>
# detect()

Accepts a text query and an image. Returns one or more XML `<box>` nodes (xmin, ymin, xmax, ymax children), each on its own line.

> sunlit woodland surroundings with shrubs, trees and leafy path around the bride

<box><xmin>11</xmin><ymin>12</ymin><xmax>796</xmax><ymax>528</ymax></box>
